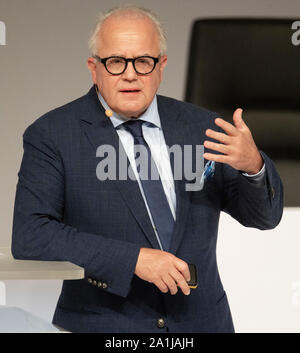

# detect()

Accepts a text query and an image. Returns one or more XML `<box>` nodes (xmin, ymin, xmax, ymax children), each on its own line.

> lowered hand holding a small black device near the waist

<box><xmin>134</xmin><ymin>248</ymin><xmax>190</xmax><ymax>295</ymax></box>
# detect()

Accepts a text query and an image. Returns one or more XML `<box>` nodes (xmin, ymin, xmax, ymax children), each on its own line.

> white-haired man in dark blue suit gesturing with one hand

<box><xmin>12</xmin><ymin>6</ymin><xmax>283</xmax><ymax>333</ymax></box>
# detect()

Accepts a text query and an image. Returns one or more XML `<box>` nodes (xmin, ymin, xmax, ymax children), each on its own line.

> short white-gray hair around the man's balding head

<box><xmin>89</xmin><ymin>5</ymin><xmax>167</xmax><ymax>55</ymax></box>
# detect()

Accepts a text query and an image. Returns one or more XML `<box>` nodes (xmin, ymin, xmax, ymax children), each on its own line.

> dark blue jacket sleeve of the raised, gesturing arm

<box><xmin>219</xmin><ymin>151</ymin><xmax>283</xmax><ymax>230</ymax></box>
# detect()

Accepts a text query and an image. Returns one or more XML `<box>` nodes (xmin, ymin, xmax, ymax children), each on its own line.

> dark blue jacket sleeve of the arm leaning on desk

<box><xmin>12</xmin><ymin>122</ymin><xmax>140</xmax><ymax>297</ymax></box>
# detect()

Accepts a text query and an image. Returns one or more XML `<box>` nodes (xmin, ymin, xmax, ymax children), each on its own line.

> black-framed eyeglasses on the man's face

<box><xmin>93</xmin><ymin>55</ymin><xmax>160</xmax><ymax>75</ymax></box>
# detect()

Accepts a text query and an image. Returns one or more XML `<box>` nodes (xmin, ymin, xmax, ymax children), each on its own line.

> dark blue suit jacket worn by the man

<box><xmin>12</xmin><ymin>87</ymin><xmax>283</xmax><ymax>333</ymax></box>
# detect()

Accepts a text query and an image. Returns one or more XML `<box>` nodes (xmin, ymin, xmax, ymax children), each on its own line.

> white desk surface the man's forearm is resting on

<box><xmin>0</xmin><ymin>247</ymin><xmax>84</xmax><ymax>280</ymax></box>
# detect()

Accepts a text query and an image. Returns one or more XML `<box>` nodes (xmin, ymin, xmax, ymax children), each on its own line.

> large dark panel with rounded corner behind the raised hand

<box><xmin>186</xmin><ymin>19</ymin><xmax>300</xmax><ymax>206</ymax></box>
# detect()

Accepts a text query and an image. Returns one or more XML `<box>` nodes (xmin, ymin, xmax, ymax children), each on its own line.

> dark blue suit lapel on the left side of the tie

<box><xmin>81</xmin><ymin>87</ymin><xmax>159</xmax><ymax>249</ymax></box>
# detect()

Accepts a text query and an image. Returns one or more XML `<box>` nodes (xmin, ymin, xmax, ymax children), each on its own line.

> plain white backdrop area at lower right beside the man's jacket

<box><xmin>217</xmin><ymin>208</ymin><xmax>300</xmax><ymax>332</ymax></box>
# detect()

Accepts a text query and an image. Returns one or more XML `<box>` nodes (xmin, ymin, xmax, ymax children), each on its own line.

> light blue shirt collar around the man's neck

<box><xmin>98</xmin><ymin>92</ymin><xmax>161</xmax><ymax>128</ymax></box>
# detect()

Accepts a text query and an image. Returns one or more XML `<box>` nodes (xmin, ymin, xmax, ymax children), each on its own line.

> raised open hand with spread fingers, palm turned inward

<box><xmin>203</xmin><ymin>108</ymin><xmax>263</xmax><ymax>174</ymax></box>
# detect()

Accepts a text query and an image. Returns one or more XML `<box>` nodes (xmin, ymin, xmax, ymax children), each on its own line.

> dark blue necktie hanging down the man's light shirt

<box><xmin>123</xmin><ymin>119</ymin><xmax>175</xmax><ymax>251</ymax></box>
